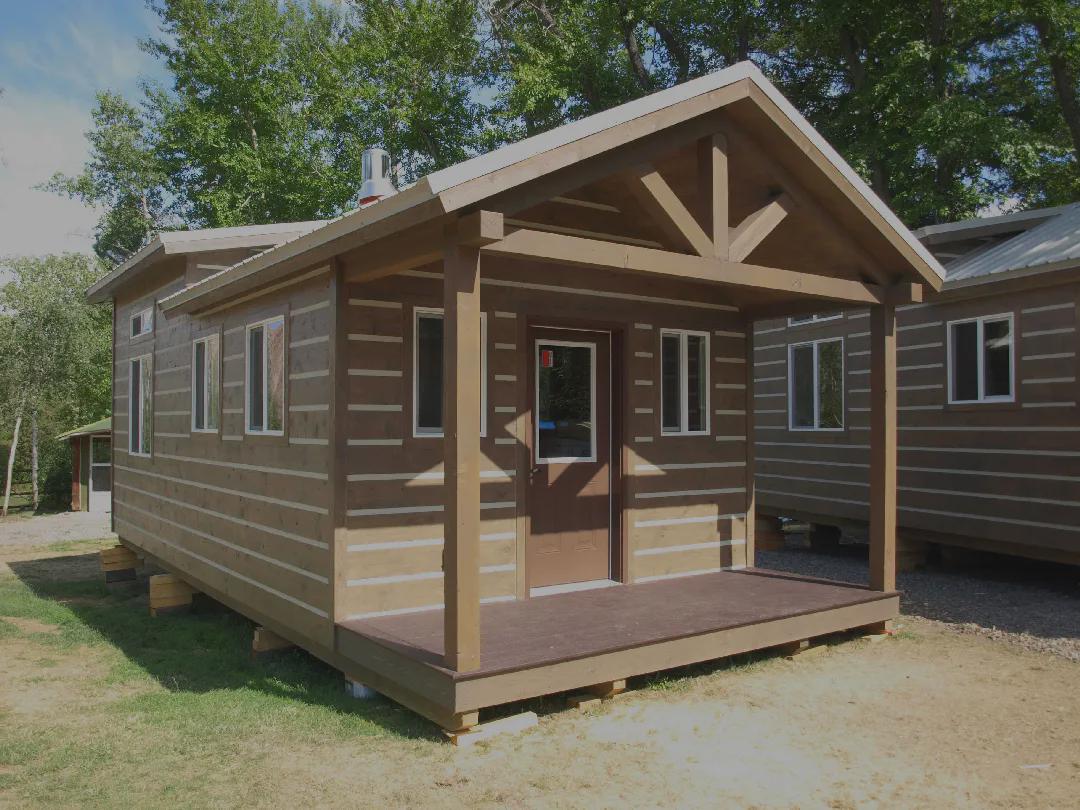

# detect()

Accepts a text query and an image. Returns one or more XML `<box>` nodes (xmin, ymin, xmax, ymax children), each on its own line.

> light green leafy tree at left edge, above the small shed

<box><xmin>0</xmin><ymin>253</ymin><xmax>112</xmax><ymax>507</ymax></box>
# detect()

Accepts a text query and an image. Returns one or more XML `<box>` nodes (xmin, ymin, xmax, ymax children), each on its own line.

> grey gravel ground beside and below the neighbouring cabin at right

<box><xmin>757</xmin><ymin>545</ymin><xmax>1080</xmax><ymax>662</ymax></box>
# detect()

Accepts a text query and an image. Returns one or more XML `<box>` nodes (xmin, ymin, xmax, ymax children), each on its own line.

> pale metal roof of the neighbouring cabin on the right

<box><xmin>945</xmin><ymin>203</ymin><xmax>1080</xmax><ymax>285</ymax></box>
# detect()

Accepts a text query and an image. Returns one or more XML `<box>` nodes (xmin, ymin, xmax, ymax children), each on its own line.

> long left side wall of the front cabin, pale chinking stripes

<box><xmin>112</xmin><ymin>253</ymin><xmax>334</xmax><ymax>647</ymax></box>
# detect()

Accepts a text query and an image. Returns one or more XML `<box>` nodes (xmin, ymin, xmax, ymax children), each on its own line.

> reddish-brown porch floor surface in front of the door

<box><xmin>341</xmin><ymin>568</ymin><xmax>895</xmax><ymax>679</ymax></box>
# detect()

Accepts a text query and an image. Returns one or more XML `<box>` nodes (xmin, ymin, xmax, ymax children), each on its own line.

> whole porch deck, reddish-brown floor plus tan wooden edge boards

<box><xmin>337</xmin><ymin>568</ymin><xmax>900</xmax><ymax>725</ymax></box>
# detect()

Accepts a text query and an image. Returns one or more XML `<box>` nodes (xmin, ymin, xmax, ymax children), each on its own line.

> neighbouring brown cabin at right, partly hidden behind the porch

<box><xmin>754</xmin><ymin>203</ymin><xmax>1080</xmax><ymax>564</ymax></box>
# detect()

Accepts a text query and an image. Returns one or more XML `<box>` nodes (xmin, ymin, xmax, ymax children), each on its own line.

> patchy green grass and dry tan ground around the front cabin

<box><xmin>0</xmin><ymin>541</ymin><xmax>1080</xmax><ymax>808</ymax></box>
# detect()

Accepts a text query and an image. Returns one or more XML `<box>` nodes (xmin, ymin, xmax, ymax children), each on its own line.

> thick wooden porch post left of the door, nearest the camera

<box><xmin>443</xmin><ymin>226</ymin><xmax>482</xmax><ymax>672</ymax></box>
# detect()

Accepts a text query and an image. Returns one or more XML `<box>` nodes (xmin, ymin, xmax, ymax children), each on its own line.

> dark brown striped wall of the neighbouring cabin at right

<box><xmin>754</xmin><ymin>284</ymin><xmax>1080</xmax><ymax>562</ymax></box>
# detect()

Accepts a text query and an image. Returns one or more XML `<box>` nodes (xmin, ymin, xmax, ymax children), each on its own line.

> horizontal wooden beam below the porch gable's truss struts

<box><xmin>482</xmin><ymin>230</ymin><xmax>883</xmax><ymax>305</ymax></box>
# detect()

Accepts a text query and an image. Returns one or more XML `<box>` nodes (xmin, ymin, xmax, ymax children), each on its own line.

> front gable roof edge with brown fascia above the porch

<box><xmin>160</xmin><ymin>62</ymin><xmax>945</xmax><ymax>312</ymax></box>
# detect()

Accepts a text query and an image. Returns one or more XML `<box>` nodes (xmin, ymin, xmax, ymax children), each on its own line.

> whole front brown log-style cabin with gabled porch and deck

<box><xmin>90</xmin><ymin>64</ymin><xmax>942</xmax><ymax>728</ymax></box>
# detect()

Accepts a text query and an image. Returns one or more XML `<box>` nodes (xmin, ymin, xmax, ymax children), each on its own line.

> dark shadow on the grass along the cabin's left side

<box><xmin>8</xmin><ymin>553</ymin><xmax>438</xmax><ymax>739</ymax></box>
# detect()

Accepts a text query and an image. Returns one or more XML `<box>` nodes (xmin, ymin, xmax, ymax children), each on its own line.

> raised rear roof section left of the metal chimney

<box><xmin>86</xmin><ymin>220</ymin><xmax>326</xmax><ymax>303</ymax></box>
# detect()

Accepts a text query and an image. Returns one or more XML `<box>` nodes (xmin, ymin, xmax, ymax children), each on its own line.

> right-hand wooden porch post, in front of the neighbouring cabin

<box><xmin>869</xmin><ymin>302</ymin><xmax>896</xmax><ymax>591</ymax></box>
